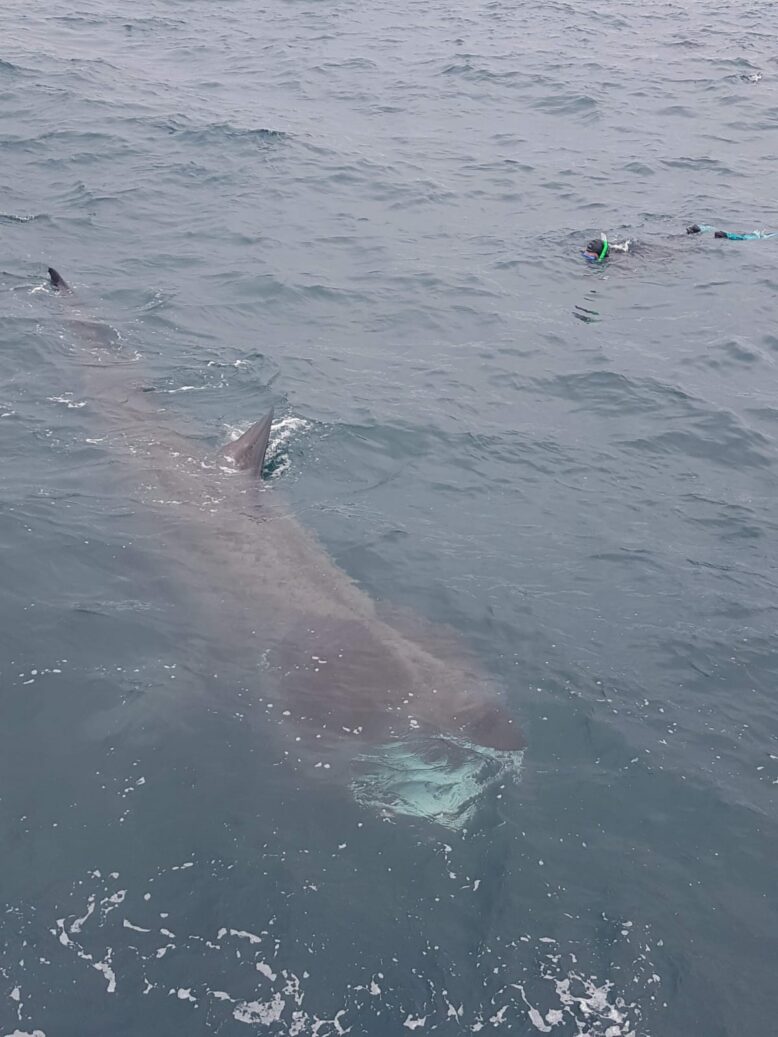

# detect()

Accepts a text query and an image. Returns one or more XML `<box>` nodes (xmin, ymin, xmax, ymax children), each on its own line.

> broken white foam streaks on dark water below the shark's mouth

<box><xmin>25</xmin><ymin>866</ymin><xmax>661</xmax><ymax>1037</ymax></box>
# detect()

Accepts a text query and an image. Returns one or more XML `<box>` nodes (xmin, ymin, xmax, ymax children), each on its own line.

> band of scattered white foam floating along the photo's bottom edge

<box><xmin>0</xmin><ymin>858</ymin><xmax>662</xmax><ymax>1037</ymax></box>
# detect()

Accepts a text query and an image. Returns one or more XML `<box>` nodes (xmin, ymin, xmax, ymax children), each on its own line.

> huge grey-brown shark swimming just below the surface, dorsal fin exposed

<box><xmin>50</xmin><ymin>270</ymin><xmax>525</xmax><ymax>819</ymax></box>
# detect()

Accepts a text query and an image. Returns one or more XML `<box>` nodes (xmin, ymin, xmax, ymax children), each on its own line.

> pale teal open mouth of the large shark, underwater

<box><xmin>351</xmin><ymin>735</ymin><xmax>524</xmax><ymax>829</ymax></box>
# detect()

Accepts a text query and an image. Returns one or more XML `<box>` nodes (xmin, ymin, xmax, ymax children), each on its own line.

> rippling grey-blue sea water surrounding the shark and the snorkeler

<box><xmin>0</xmin><ymin>0</ymin><xmax>778</xmax><ymax>1037</ymax></box>
